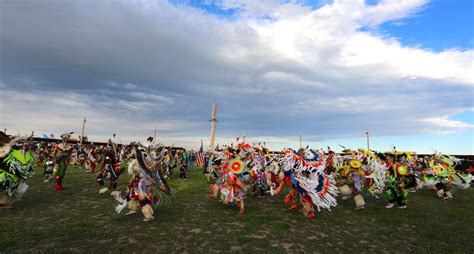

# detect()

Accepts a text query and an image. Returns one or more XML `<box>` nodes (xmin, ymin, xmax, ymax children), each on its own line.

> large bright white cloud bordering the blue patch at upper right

<box><xmin>244</xmin><ymin>1</ymin><xmax>474</xmax><ymax>85</ymax></box>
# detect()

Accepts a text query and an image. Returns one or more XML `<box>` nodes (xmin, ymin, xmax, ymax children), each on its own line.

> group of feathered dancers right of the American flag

<box><xmin>207</xmin><ymin>143</ymin><xmax>473</xmax><ymax>218</ymax></box>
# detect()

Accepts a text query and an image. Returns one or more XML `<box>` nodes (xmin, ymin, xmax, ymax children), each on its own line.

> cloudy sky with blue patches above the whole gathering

<box><xmin>0</xmin><ymin>0</ymin><xmax>474</xmax><ymax>154</ymax></box>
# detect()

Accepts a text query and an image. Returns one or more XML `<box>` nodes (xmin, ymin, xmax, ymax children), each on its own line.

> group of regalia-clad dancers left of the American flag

<box><xmin>0</xmin><ymin>132</ymin><xmax>188</xmax><ymax>221</ymax></box>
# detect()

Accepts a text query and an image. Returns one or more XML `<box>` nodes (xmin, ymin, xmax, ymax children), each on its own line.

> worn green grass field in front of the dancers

<box><xmin>0</xmin><ymin>167</ymin><xmax>474</xmax><ymax>253</ymax></box>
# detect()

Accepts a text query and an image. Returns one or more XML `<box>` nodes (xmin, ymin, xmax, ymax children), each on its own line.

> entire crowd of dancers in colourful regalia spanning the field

<box><xmin>0</xmin><ymin>132</ymin><xmax>473</xmax><ymax>221</ymax></box>
